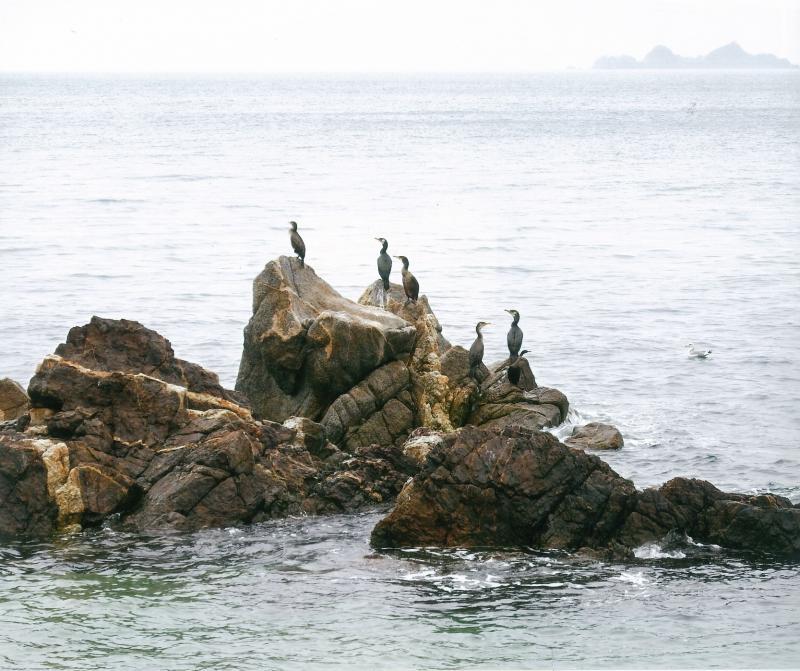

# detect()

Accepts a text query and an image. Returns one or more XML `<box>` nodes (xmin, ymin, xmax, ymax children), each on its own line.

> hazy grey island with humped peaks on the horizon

<box><xmin>594</xmin><ymin>42</ymin><xmax>797</xmax><ymax>70</ymax></box>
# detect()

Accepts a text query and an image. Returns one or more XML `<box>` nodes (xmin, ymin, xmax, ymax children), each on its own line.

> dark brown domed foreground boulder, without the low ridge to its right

<box><xmin>372</xmin><ymin>427</ymin><xmax>635</xmax><ymax>548</ymax></box>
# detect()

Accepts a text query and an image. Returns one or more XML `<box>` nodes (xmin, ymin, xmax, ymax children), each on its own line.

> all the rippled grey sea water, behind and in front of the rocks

<box><xmin>0</xmin><ymin>72</ymin><xmax>800</xmax><ymax>669</ymax></box>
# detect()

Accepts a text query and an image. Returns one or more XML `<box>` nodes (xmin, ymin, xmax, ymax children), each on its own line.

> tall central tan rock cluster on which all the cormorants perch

<box><xmin>236</xmin><ymin>257</ymin><xmax>567</xmax><ymax>451</ymax></box>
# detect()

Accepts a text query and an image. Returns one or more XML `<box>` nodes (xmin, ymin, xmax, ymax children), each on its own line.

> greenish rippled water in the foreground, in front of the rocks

<box><xmin>0</xmin><ymin>512</ymin><xmax>800</xmax><ymax>669</ymax></box>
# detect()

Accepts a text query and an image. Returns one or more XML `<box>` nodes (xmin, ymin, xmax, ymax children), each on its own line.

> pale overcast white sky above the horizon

<box><xmin>0</xmin><ymin>0</ymin><xmax>800</xmax><ymax>72</ymax></box>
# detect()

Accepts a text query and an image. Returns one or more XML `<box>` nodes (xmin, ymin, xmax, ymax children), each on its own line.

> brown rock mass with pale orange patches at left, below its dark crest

<box><xmin>0</xmin><ymin>320</ymin><xmax>424</xmax><ymax>534</ymax></box>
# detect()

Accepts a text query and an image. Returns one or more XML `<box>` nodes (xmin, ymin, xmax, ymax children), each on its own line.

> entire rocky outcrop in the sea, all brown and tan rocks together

<box><xmin>6</xmin><ymin>257</ymin><xmax>800</xmax><ymax>557</ymax></box>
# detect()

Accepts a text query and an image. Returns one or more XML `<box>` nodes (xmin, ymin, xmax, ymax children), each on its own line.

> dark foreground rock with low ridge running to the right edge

<box><xmin>372</xmin><ymin>427</ymin><xmax>800</xmax><ymax>556</ymax></box>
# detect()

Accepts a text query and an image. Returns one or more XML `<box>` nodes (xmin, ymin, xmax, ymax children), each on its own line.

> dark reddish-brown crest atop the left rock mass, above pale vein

<box><xmin>55</xmin><ymin>317</ymin><xmax>246</xmax><ymax>405</ymax></box>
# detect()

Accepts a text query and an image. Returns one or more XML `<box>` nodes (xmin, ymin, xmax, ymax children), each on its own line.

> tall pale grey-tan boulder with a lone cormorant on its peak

<box><xmin>236</xmin><ymin>256</ymin><xmax>416</xmax><ymax>421</ymax></box>
